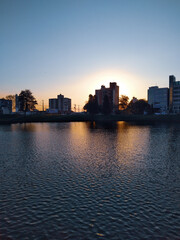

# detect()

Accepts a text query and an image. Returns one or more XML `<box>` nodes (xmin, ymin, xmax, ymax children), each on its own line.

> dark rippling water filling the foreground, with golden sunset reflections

<box><xmin>0</xmin><ymin>122</ymin><xmax>180</xmax><ymax>240</ymax></box>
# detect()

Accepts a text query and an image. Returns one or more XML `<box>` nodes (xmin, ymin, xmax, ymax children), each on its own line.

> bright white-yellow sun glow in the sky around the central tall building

<box><xmin>34</xmin><ymin>69</ymin><xmax>147</xmax><ymax>110</ymax></box>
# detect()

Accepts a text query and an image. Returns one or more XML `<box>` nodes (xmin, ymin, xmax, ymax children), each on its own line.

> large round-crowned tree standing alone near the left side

<box><xmin>19</xmin><ymin>89</ymin><xmax>37</xmax><ymax>112</ymax></box>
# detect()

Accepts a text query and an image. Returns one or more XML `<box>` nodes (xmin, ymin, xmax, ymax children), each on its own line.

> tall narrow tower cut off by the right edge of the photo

<box><xmin>169</xmin><ymin>75</ymin><xmax>180</xmax><ymax>113</ymax></box>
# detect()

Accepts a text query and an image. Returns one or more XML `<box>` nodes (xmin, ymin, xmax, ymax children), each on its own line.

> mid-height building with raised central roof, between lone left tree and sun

<box><xmin>49</xmin><ymin>94</ymin><xmax>71</xmax><ymax>114</ymax></box>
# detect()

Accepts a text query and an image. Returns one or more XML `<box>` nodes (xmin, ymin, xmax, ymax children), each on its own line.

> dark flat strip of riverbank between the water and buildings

<box><xmin>0</xmin><ymin>114</ymin><xmax>180</xmax><ymax>124</ymax></box>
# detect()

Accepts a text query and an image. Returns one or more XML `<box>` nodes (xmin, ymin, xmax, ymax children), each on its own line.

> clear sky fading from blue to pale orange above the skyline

<box><xmin>0</xmin><ymin>0</ymin><xmax>180</xmax><ymax>108</ymax></box>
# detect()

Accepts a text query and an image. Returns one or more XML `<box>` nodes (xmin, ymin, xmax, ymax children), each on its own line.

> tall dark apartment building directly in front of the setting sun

<box><xmin>95</xmin><ymin>82</ymin><xmax>119</xmax><ymax>111</ymax></box>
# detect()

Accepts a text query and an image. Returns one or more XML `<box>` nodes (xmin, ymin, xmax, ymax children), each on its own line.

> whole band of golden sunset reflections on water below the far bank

<box><xmin>11</xmin><ymin>122</ymin><xmax>150</xmax><ymax>169</ymax></box>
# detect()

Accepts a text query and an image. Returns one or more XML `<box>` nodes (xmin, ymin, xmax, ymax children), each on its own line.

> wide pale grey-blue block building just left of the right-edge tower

<box><xmin>148</xmin><ymin>86</ymin><xmax>169</xmax><ymax>113</ymax></box>
